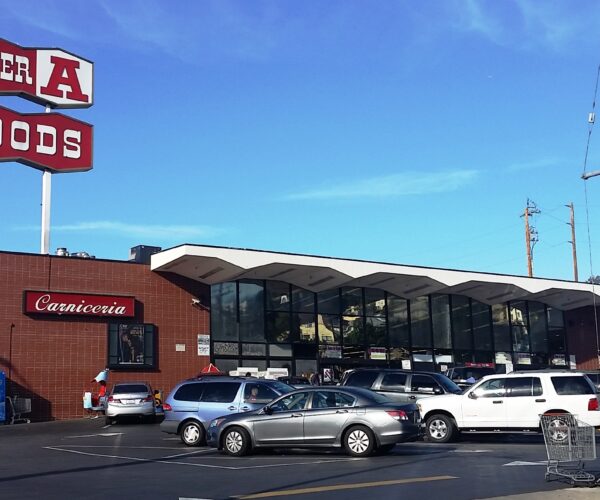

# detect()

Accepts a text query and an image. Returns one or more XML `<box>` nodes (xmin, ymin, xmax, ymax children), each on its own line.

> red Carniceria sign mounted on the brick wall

<box><xmin>23</xmin><ymin>290</ymin><xmax>135</xmax><ymax>318</ymax></box>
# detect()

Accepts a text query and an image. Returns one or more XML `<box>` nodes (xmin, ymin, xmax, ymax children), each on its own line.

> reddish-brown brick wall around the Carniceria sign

<box><xmin>0</xmin><ymin>252</ymin><xmax>210</xmax><ymax>420</ymax></box>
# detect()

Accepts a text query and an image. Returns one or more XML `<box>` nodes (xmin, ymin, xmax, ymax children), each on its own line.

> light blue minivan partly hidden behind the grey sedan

<box><xmin>160</xmin><ymin>375</ymin><xmax>294</xmax><ymax>446</ymax></box>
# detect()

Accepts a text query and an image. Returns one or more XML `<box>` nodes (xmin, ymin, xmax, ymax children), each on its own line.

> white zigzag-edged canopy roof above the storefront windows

<box><xmin>151</xmin><ymin>245</ymin><xmax>600</xmax><ymax>310</ymax></box>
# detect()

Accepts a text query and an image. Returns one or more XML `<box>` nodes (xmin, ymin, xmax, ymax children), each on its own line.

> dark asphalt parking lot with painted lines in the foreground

<box><xmin>0</xmin><ymin>419</ymin><xmax>600</xmax><ymax>500</ymax></box>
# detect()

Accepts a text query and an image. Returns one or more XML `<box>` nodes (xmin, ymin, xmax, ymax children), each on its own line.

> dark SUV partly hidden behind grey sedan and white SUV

<box><xmin>340</xmin><ymin>368</ymin><xmax>462</xmax><ymax>403</ymax></box>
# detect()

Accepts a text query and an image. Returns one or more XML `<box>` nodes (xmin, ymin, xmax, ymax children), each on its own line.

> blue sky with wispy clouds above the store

<box><xmin>0</xmin><ymin>0</ymin><xmax>600</xmax><ymax>279</ymax></box>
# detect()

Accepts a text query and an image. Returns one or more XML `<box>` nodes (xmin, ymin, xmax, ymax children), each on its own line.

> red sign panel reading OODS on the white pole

<box><xmin>0</xmin><ymin>106</ymin><xmax>93</xmax><ymax>173</ymax></box>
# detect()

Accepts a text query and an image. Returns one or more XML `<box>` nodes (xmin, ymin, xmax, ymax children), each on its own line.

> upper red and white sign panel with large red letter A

<box><xmin>0</xmin><ymin>39</ymin><xmax>94</xmax><ymax>108</ymax></box>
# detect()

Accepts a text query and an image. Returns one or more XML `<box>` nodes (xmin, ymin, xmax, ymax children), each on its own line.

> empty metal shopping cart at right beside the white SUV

<box><xmin>540</xmin><ymin>413</ymin><xmax>598</xmax><ymax>486</ymax></box>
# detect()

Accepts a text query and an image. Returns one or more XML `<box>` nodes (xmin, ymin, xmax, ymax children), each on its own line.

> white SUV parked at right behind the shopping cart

<box><xmin>417</xmin><ymin>370</ymin><xmax>600</xmax><ymax>443</ymax></box>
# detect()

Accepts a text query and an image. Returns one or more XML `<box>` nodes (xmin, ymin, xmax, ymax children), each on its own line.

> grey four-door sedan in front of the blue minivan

<box><xmin>207</xmin><ymin>387</ymin><xmax>420</xmax><ymax>457</ymax></box>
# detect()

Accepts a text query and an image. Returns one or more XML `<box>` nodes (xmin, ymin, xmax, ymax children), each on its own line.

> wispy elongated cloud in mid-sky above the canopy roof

<box><xmin>283</xmin><ymin>170</ymin><xmax>478</xmax><ymax>200</ymax></box>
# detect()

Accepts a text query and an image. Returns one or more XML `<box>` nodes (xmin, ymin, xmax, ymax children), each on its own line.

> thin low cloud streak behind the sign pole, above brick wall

<box><xmin>13</xmin><ymin>221</ymin><xmax>224</xmax><ymax>241</ymax></box>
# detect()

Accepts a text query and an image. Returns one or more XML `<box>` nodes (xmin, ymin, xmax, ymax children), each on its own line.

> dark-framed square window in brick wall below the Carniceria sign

<box><xmin>108</xmin><ymin>323</ymin><xmax>156</xmax><ymax>370</ymax></box>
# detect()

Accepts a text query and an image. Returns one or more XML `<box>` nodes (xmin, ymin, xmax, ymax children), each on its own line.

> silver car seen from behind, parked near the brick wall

<box><xmin>105</xmin><ymin>382</ymin><xmax>156</xmax><ymax>425</ymax></box>
